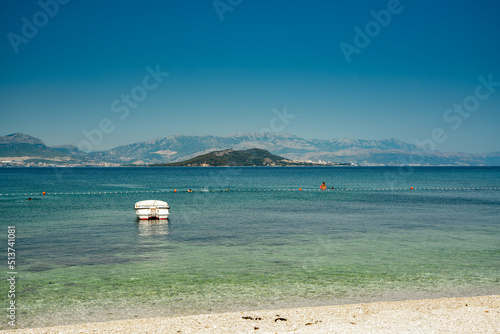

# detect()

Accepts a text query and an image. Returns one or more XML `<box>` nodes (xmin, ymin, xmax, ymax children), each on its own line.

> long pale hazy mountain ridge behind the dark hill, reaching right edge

<box><xmin>96</xmin><ymin>133</ymin><xmax>500</xmax><ymax>166</ymax></box>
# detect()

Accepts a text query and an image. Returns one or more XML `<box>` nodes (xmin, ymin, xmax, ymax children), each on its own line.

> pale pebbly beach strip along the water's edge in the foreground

<box><xmin>2</xmin><ymin>295</ymin><xmax>500</xmax><ymax>333</ymax></box>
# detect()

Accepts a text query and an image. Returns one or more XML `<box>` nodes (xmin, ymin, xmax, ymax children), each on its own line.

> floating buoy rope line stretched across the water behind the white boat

<box><xmin>0</xmin><ymin>187</ymin><xmax>500</xmax><ymax>197</ymax></box>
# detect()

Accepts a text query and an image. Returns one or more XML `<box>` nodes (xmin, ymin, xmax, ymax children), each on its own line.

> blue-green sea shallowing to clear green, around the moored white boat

<box><xmin>0</xmin><ymin>167</ymin><xmax>500</xmax><ymax>329</ymax></box>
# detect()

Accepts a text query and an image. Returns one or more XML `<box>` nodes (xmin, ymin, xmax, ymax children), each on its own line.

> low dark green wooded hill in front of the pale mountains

<box><xmin>158</xmin><ymin>148</ymin><xmax>292</xmax><ymax>167</ymax></box>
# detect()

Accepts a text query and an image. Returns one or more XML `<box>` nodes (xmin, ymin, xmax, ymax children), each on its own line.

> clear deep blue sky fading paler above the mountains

<box><xmin>0</xmin><ymin>0</ymin><xmax>500</xmax><ymax>153</ymax></box>
